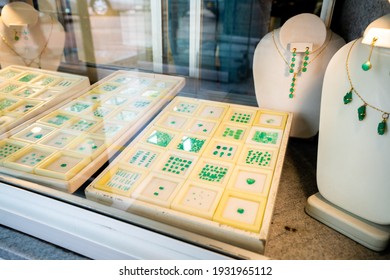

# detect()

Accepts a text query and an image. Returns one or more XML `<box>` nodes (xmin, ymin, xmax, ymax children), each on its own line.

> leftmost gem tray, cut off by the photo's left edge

<box><xmin>0</xmin><ymin>65</ymin><xmax>90</xmax><ymax>134</ymax></box>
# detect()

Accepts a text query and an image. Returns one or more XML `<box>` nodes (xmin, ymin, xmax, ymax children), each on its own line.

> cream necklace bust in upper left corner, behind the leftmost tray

<box><xmin>0</xmin><ymin>2</ymin><xmax>65</xmax><ymax>70</ymax></box>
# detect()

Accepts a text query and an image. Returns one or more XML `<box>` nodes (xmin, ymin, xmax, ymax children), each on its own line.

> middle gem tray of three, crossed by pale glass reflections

<box><xmin>0</xmin><ymin>71</ymin><xmax>185</xmax><ymax>193</ymax></box>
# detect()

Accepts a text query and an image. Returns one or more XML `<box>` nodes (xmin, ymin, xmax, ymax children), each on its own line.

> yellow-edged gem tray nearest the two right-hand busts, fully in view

<box><xmin>85</xmin><ymin>97</ymin><xmax>292</xmax><ymax>253</ymax></box>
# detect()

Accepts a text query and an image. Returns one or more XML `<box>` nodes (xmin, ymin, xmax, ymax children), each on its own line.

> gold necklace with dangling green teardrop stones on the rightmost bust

<box><xmin>343</xmin><ymin>38</ymin><xmax>390</xmax><ymax>135</ymax></box>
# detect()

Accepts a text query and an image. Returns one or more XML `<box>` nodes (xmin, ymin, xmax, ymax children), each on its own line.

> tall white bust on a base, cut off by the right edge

<box><xmin>305</xmin><ymin>14</ymin><xmax>390</xmax><ymax>251</ymax></box>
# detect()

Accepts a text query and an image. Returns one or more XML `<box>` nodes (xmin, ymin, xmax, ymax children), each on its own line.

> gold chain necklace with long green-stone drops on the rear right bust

<box><xmin>272</xmin><ymin>30</ymin><xmax>333</xmax><ymax>98</ymax></box>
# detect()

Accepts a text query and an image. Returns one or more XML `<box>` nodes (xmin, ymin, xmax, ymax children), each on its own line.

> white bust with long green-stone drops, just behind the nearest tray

<box><xmin>253</xmin><ymin>14</ymin><xmax>345</xmax><ymax>138</ymax></box>
